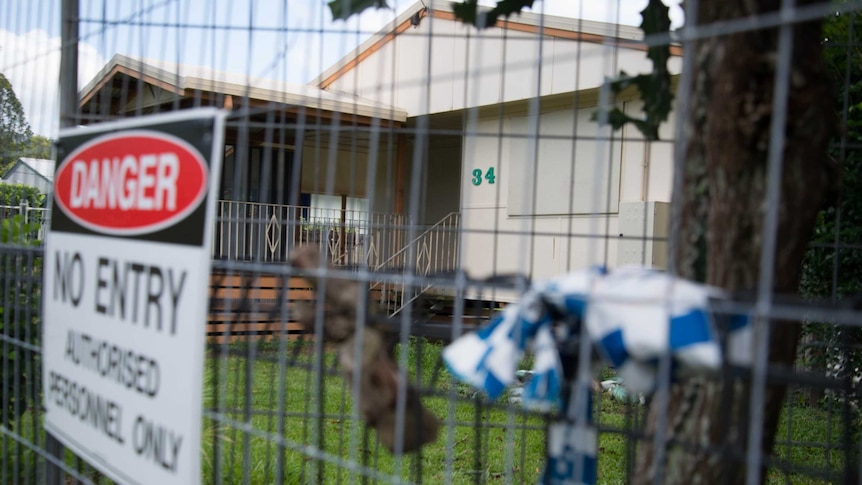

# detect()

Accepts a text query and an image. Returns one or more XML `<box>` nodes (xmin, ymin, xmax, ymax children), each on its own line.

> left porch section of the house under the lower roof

<box><xmin>80</xmin><ymin>54</ymin><xmax>406</xmax><ymax>265</ymax></box>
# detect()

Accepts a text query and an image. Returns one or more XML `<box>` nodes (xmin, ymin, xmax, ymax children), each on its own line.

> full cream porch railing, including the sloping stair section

<box><xmin>212</xmin><ymin>200</ymin><xmax>460</xmax><ymax>276</ymax></box>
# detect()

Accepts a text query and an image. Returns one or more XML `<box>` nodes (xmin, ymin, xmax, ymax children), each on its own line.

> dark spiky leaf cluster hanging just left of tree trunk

<box><xmin>593</xmin><ymin>0</ymin><xmax>673</xmax><ymax>140</ymax></box>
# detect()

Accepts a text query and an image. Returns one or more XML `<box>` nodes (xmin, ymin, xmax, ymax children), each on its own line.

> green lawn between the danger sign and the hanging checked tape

<box><xmin>203</xmin><ymin>343</ymin><xmax>545</xmax><ymax>483</ymax></box>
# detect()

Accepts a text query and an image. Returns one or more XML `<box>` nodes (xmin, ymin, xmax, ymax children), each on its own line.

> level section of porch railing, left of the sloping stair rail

<box><xmin>213</xmin><ymin>200</ymin><xmax>406</xmax><ymax>268</ymax></box>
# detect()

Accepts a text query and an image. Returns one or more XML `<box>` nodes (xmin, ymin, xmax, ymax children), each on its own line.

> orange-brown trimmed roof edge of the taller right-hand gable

<box><xmin>309</xmin><ymin>0</ymin><xmax>682</xmax><ymax>89</ymax></box>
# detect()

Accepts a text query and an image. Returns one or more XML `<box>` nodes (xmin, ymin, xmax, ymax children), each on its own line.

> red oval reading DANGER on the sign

<box><xmin>54</xmin><ymin>131</ymin><xmax>207</xmax><ymax>235</ymax></box>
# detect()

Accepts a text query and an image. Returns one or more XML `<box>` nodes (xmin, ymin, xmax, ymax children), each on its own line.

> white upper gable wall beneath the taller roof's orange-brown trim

<box><xmin>327</xmin><ymin>16</ymin><xmax>681</xmax><ymax>117</ymax></box>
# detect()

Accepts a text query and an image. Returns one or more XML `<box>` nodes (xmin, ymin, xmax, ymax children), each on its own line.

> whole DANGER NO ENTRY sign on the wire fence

<box><xmin>42</xmin><ymin>109</ymin><xmax>224</xmax><ymax>484</ymax></box>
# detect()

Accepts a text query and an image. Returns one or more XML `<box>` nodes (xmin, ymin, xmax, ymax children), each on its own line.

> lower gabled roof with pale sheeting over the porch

<box><xmin>79</xmin><ymin>54</ymin><xmax>407</xmax><ymax>122</ymax></box>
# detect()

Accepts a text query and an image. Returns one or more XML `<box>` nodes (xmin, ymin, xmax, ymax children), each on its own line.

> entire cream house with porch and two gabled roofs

<box><xmin>81</xmin><ymin>0</ymin><xmax>681</xmax><ymax>300</ymax></box>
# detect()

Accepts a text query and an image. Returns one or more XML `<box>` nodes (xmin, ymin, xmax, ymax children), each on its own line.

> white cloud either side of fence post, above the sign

<box><xmin>0</xmin><ymin>29</ymin><xmax>105</xmax><ymax>138</ymax></box>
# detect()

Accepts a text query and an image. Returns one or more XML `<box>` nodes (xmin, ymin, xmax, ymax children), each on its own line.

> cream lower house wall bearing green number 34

<box><xmin>461</xmin><ymin>101</ymin><xmax>673</xmax><ymax>286</ymax></box>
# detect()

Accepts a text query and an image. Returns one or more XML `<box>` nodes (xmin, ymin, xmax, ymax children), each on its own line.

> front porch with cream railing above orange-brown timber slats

<box><xmin>207</xmin><ymin>200</ymin><xmax>466</xmax><ymax>343</ymax></box>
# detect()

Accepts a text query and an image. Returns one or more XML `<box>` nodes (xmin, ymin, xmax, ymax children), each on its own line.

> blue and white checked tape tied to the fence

<box><xmin>443</xmin><ymin>267</ymin><xmax>752</xmax><ymax>484</ymax></box>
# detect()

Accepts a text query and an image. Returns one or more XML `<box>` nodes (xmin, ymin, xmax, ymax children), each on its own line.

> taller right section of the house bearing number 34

<box><xmin>311</xmin><ymin>2</ymin><xmax>681</xmax><ymax>288</ymax></box>
